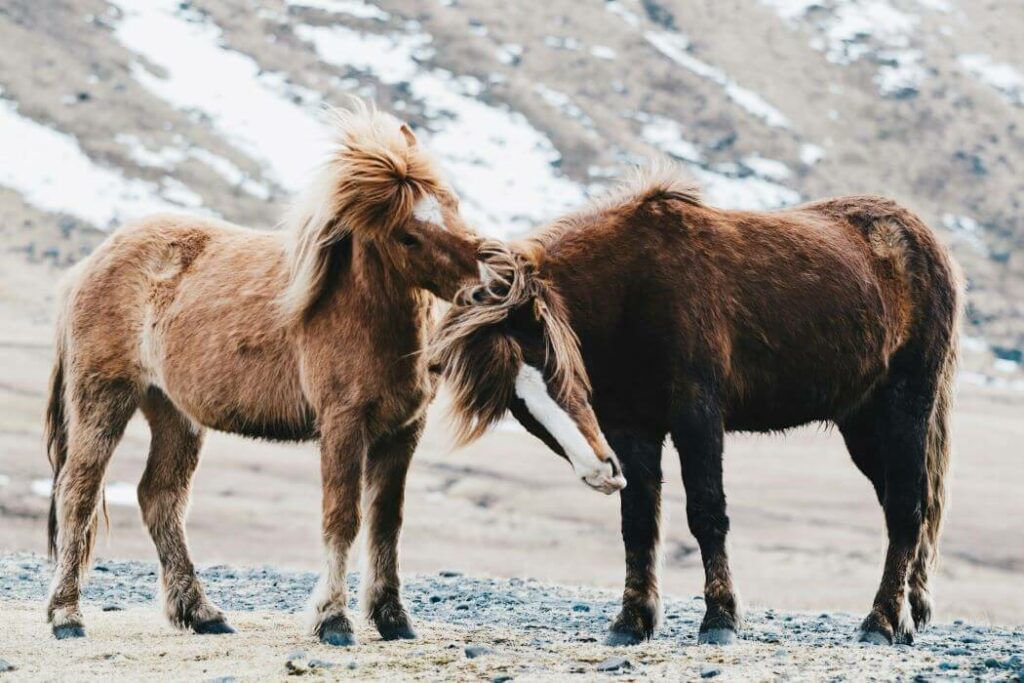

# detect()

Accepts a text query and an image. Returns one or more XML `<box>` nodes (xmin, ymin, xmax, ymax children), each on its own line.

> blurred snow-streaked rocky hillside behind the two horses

<box><xmin>0</xmin><ymin>0</ymin><xmax>1024</xmax><ymax>385</ymax></box>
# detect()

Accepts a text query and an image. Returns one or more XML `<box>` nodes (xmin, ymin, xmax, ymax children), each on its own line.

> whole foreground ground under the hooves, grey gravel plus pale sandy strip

<box><xmin>0</xmin><ymin>553</ymin><xmax>1024</xmax><ymax>681</ymax></box>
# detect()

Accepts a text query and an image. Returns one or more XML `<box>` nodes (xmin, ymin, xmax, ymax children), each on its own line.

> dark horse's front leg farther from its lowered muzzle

<box><xmin>672</xmin><ymin>397</ymin><xmax>740</xmax><ymax>645</ymax></box>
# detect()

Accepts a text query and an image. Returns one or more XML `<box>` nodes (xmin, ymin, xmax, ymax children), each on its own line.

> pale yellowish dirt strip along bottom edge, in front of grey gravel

<box><xmin>0</xmin><ymin>602</ymin><xmax>999</xmax><ymax>681</ymax></box>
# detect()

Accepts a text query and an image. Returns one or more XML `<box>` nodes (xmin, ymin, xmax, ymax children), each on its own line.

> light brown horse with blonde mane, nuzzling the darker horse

<box><xmin>46</xmin><ymin>103</ymin><xmax>479</xmax><ymax>645</ymax></box>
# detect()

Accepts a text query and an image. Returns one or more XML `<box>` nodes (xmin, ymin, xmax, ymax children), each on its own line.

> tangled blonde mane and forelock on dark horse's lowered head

<box><xmin>429</xmin><ymin>240</ymin><xmax>590</xmax><ymax>445</ymax></box>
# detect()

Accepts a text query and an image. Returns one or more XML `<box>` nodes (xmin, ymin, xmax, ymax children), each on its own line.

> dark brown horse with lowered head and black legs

<box><xmin>434</xmin><ymin>166</ymin><xmax>961</xmax><ymax>644</ymax></box>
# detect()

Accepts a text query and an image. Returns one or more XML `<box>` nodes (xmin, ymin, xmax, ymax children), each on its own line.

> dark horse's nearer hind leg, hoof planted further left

<box><xmin>858</xmin><ymin>376</ymin><xmax>933</xmax><ymax>644</ymax></box>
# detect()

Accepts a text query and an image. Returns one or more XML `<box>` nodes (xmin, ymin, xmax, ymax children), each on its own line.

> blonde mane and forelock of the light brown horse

<box><xmin>281</xmin><ymin>99</ymin><xmax>443</xmax><ymax>321</ymax></box>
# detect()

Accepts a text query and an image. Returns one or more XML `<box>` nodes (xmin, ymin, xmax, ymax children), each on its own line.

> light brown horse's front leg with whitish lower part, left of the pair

<box><xmin>313</xmin><ymin>412</ymin><xmax>370</xmax><ymax>646</ymax></box>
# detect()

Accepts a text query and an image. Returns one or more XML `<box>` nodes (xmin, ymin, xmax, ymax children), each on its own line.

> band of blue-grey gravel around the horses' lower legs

<box><xmin>0</xmin><ymin>554</ymin><xmax>1024</xmax><ymax>680</ymax></box>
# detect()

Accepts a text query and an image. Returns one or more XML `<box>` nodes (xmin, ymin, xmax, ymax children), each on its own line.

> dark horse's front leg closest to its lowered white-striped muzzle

<box><xmin>605</xmin><ymin>430</ymin><xmax>662</xmax><ymax>645</ymax></box>
